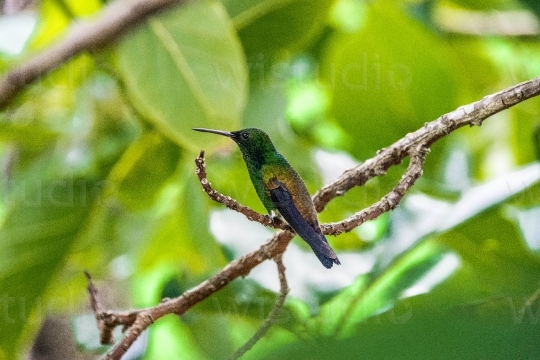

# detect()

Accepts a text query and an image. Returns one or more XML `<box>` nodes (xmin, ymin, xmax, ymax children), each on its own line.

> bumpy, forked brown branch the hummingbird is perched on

<box><xmin>89</xmin><ymin>77</ymin><xmax>540</xmax><ymax>360</ymax></box>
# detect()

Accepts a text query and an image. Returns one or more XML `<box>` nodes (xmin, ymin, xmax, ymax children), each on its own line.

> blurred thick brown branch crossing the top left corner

<box><xmin>0</xmin><ymin>0</ymin><xmax>187</xmax><ymax>110</ymax></box>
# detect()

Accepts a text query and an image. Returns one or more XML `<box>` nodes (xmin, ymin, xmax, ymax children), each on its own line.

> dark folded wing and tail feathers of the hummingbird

<box><xmin>270</xmin><ymin>178</ymin><xmax>339</xmax><ymax>268</ymax></box>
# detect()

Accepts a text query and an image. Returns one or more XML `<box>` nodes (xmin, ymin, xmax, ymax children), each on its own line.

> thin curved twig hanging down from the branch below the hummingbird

<box><xmin>229</xmin><ymin>254</ymin><xmax>289</xmax><ymax>360</ymax></box>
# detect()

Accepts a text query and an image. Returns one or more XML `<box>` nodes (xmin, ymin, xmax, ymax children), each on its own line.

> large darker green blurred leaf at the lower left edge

<box><xmin>0</xmin><ymin>178</ymin><xmax>99</xmax><ymax>354</ymax></box>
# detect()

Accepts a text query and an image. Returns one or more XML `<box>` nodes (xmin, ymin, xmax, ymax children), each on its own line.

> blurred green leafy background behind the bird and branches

<box><xmin>0</xmin><ymin>0</ymin><xmax>540</xmax><ymax>359</ymax></box>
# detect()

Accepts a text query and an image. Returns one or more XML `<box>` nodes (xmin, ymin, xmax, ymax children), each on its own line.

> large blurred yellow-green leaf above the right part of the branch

<box><xmin>322</xmin><ymin>1</ymin><xmax>463</xmax><ymax>159</ymax></box>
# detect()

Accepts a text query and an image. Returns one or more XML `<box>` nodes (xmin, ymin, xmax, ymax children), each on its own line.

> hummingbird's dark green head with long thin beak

<box><xmin>193</xmin><ymin>128</ymin><xmax>277</xmax><ymax>163</ymax></box>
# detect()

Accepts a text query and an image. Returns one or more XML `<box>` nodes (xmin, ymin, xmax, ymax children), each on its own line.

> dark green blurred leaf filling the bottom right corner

<box><xmin>264</xmin><ymin>295</ymin><xmax>540</xmax><ymax>360</ymax></box>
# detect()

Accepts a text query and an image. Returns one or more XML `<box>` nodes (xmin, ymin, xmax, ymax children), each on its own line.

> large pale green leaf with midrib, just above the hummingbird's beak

<box><xmin>117</xmin><ymin>1</ymin><xmax>247</xmax><ymax>150</ymax></box>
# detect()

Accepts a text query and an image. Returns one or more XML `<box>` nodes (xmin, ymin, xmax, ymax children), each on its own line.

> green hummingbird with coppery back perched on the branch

<box><xmin>193</xmin><ymin>128</ymin><xmax>341</xmax><ymax>269</ymax></box>
